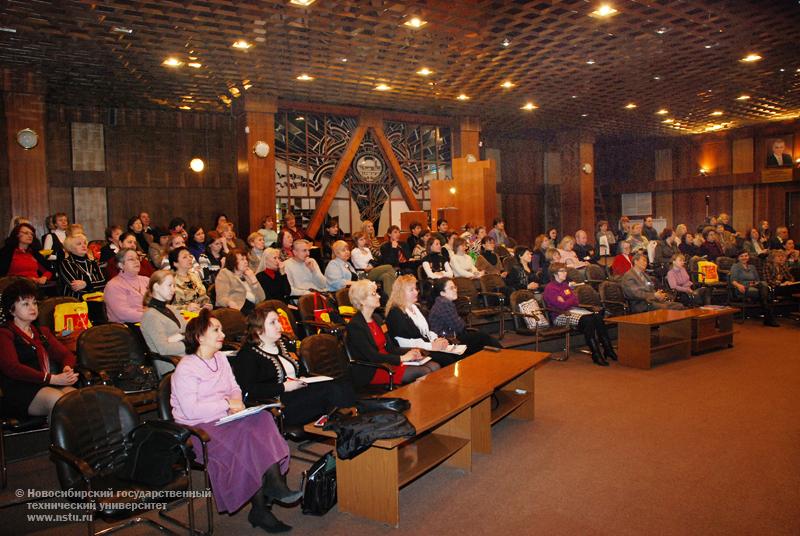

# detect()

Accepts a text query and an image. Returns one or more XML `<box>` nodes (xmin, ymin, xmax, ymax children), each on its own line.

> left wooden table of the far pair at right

<box><xmin>608</xmin><ymin>309</ymin><xmax>697</xmax><ymax>369</ymax></box>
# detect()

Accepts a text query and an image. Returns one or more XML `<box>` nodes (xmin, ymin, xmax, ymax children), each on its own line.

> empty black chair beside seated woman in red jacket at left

<box><xmin>77</xmin><ymin>323</ymin><xmax>156</xmax><ymax>413</ymax></box>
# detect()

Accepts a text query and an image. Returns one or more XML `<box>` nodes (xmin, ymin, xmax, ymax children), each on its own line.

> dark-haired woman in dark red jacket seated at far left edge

<box><xmin>0</xmin><ymin>279</ymin><xmax>78</xmax><ymax>419</ymax></box>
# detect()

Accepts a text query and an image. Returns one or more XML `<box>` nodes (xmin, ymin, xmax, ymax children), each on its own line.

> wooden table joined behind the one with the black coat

<box><xmin>422</xmin><ymin>350</ymin><xmax>550</xmax><ymax>454</ymax></box>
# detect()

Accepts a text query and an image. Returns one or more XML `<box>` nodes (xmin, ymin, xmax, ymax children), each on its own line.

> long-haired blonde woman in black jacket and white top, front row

<box><xmin>386</xmin><ymin>276</ymin><xmax>461</xmax><ymax>367</ymax></box>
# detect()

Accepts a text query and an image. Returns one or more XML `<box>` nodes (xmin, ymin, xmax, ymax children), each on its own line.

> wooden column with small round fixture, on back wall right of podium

<box><xmin>557</xmin><ymin>132</ymin><xmax>595</xmax><ymax>237</ymax></box>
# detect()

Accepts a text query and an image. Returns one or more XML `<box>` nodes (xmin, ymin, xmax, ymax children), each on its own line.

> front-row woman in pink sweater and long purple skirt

<box><xmin>170</xmin><ymin>309</ymin><xmax>302</xmax><ymax>532</ymax></box>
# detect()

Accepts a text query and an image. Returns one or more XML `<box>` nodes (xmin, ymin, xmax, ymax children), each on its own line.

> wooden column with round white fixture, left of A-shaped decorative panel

<box><xmin>234</xmin><ymin>95</ymin><xmax>278</xmax><ymax>239</ymax></box>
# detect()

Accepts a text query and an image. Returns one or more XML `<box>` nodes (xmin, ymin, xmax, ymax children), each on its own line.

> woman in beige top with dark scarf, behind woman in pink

<box><xmin>142</xmin><ymin>270</ymin><xmax>186</xmax><ymax>377</ymax></box>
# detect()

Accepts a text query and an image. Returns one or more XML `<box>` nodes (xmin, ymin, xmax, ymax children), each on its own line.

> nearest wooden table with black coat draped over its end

<box><xmin>304</xmin><ymin>378</ymin><xmax>489</xmax><ymax>527</ymax></box>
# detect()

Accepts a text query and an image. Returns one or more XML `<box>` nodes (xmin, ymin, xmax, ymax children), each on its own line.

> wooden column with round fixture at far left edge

<box><xmin>2</xmin><ymin>69</ymin><xmax>50</xmax><ymax>237</ymax></box>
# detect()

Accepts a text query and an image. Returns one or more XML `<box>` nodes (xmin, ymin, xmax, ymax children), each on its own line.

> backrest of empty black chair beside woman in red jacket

<box><xmin>76</xmin><ymin>323</ymin><xmax>145</xmax><ymax>378</ymax></box>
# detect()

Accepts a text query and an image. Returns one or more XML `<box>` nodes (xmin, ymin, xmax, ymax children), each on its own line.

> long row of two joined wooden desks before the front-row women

<box><xmin>305</xmin><ymin>350</ymin><xmax>549</xmax><ymax>526</ymax></box>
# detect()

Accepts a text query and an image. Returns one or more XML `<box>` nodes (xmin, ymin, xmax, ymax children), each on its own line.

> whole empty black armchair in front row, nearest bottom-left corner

<box><xmin>50</xmin><ymin>386</ymin><xmax>206</xmax><ymax>535</ymax></box>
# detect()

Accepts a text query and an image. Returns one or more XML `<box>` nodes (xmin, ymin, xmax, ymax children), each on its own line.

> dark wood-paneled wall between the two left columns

<box><xmin>46</xmin><ymin>106</ymin><xmax>238</xmax><ymax>238</ymax></box>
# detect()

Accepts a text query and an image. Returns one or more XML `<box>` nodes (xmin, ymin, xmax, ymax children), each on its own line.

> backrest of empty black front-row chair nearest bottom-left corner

<box><xmin>50</xmin><ymin>385</ymin><xmax>139</xmax><ymax>490</ymax></box>
